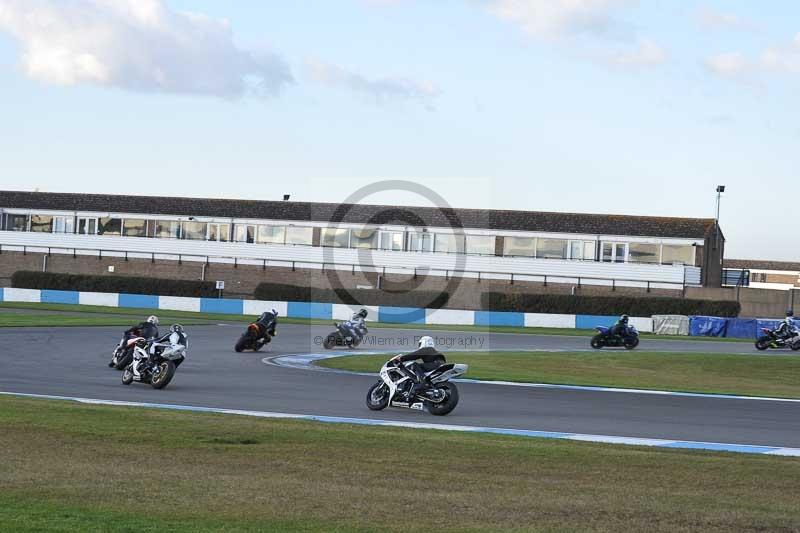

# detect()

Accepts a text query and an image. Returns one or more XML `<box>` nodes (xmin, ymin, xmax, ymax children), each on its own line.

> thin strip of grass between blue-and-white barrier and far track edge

<box><xmin>0</xmin><ymin>302</ymin><xmax>752</xmax><ymax>342</ymax></box>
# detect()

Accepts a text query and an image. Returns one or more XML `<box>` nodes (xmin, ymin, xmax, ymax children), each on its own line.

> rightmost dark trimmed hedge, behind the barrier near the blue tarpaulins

<box><xmin>481</xmin><ymin>292</ymin><xmax>742</xmax><ymax>317</ymax></box>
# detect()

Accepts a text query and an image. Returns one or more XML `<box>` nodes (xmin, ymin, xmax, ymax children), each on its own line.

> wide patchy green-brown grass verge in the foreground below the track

<box><xmin>0</xmin><ymin>397</ymin><xmax>800</xmax><ymax>532</ymax></box>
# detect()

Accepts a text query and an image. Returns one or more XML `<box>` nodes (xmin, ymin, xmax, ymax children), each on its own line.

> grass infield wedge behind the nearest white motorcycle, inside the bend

<box><xmin>317</xmin><ymin>351</ymin><xmax>800</xmax><ymax>398</ymax></box>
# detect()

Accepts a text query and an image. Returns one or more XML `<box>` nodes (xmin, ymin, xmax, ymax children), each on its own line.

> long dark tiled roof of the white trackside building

<box><xmin>0</xmin><ymin>187</ymin><xmax>714</xmax><ymax>239</ymax></box>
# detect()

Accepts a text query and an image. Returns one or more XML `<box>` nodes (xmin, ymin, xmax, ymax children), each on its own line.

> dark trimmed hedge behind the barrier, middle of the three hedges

<box><xmin>255</xmin><ymin>283</ymin><xmax>450</xmax><ymax>309</ymax></box>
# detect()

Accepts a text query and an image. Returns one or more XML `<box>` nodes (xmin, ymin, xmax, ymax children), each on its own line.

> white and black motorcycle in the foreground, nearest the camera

<box><xmin>367</xmin><ymin>360</ymin><xmax>469</xmax><ymax>416</ymax></box>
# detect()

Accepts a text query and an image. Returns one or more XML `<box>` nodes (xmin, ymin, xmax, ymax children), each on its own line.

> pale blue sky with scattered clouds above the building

<box><xmin>0</xmin><ymin>0</ymin><xmax>800</xmax><ymax>260</ymax></box>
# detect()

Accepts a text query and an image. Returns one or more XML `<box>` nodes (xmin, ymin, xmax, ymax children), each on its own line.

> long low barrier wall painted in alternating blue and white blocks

<box><xmin>0</xmin><ymin>288</ymin><xmax>653</xmax><ymax>332</ymax></box>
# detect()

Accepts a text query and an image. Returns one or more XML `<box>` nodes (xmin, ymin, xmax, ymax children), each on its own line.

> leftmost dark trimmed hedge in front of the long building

<box><xmin>11</xmin><ymin>270</ymin><xmax>218</xmax><ymax>298</ymax></box>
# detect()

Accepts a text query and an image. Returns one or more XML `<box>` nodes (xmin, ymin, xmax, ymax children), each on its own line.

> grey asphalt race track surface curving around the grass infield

<box><xmin>0</xmin><ymin>324</ymin><xmax>800</xmax><ymax>447</ymax></box>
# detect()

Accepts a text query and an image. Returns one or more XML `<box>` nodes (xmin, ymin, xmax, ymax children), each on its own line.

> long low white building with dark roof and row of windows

<box><xmin>0</xmin><ymin>191</ymin><xmax>725</xmax><ymax>289</ymax></box>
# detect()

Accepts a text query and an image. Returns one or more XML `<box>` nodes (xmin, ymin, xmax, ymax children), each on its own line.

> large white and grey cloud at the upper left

<box><xmin>0</xmin><ymin>0</ymin><xmax>293</xmax><ymax>98</ymax></box>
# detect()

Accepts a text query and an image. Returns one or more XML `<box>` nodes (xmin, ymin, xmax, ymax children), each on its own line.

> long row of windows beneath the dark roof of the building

<box><xmin>4</xmin><ymin>210</ymin><xmax>695</xmax><ymax>265</ymax></box>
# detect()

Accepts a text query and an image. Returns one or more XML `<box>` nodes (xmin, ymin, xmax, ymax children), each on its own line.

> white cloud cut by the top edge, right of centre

<box><xmin>489</xmin><ymin>0</ymin><xmax>631</xmax><ymax>38</ymax></box>
